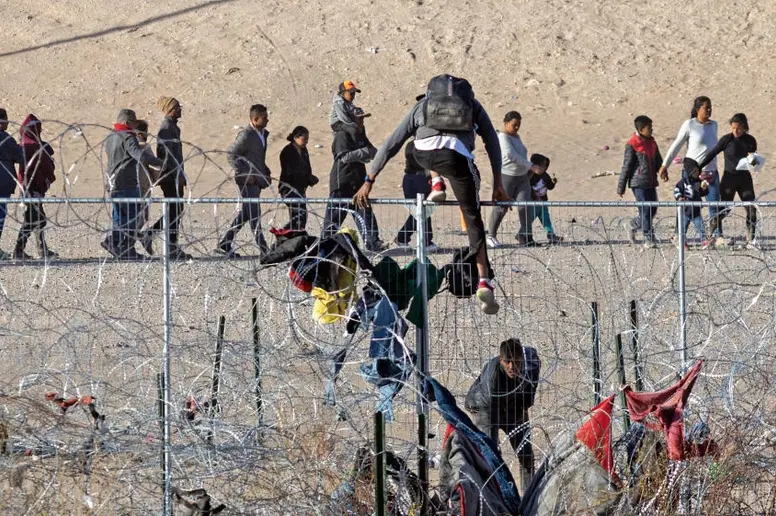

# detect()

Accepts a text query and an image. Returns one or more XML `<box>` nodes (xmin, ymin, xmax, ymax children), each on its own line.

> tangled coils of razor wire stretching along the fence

<box><xmin>0</xmin><ymin>121</ymin><xmax>776</xmax><ymax>514</ymax></box>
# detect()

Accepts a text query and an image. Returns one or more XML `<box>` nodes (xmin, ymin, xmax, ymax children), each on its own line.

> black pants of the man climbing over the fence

<box><xmin>414</xmin><ymin>149</ymin><xmax>485</xmax><ymax>254</ymax></box>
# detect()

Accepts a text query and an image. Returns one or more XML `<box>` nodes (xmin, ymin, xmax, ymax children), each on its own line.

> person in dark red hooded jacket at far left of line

<box><xmin>13</xmin><ymin>114</ymin><xmax>59</xmax><ymax>260</ymax></box>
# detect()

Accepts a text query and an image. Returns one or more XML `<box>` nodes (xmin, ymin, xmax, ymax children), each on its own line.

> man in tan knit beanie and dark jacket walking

<box><xmin>140</xmin><ymin>97</ymin><xmax>191</xmax><ymax>260</ymax></box>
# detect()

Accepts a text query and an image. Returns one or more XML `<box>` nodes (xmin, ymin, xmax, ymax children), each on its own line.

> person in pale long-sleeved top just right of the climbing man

<box><xmin>485</xmin><ymin>111</ymin><xmax>541</xmax><ymax>248</ymax></box>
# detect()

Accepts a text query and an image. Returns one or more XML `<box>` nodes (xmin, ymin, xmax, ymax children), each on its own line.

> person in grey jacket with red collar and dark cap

<box><xmin>101</xmin><ymin>109</ymin><xmax>162</xmax><ymax>260</ymax></box>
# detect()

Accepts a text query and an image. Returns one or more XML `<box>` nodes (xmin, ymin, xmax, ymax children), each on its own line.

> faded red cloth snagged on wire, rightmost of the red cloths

<box><xmin>623</xmin><ymin>360</ymin><xmax>703</xmax><ymax>460</ymax></box>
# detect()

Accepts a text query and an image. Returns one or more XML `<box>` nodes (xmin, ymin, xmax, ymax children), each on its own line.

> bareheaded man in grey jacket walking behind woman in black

<box><xmin>216</xmin><ymin>104</ymin><xmax>272</xmax><ymax>258</ymax></box>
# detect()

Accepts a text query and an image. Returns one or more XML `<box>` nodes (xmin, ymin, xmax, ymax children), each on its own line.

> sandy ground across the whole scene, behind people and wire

<box><xmin>0</xmin><ymin>0</ymin><xmax>776</xmax><ymax>514</ymax></box>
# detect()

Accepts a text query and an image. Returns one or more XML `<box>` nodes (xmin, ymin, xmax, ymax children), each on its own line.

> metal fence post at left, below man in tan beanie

<box><xmin>162</xmin><ymin>202</ymin><xmax>172</xmax><ymax>516</ymax></box>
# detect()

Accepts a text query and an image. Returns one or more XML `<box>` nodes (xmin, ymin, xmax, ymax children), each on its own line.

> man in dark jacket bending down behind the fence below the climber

<box><xmin>464</xmin><ymin>338</ymin><xmax>542</xmax><ymax>496</ymax></box>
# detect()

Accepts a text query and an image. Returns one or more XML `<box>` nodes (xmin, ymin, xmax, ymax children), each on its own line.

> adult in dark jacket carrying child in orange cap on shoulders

<box><xmin>322</xmin><ymin>108</ymin><xmax>386</xmax><ymax>252</ymax></box>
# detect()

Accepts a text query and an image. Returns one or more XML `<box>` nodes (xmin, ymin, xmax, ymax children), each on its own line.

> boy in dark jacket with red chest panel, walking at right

<box><xmin>617</xmin><ymin>115</ymin><xmax>662</xmax><ymax>248</ymax></box>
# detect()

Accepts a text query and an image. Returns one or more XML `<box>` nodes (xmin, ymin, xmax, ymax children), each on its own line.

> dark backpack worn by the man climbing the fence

<box><xmin>423</xmin><ymin>74</ymin><xmax>474</xmax><ymax>133</ymax></box>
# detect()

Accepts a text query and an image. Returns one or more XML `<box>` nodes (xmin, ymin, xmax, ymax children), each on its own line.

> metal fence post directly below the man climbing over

<box><xmin>415</xmin><ymin>194</ymin><xmax>429</xmax><ymax>516</ymax></box>
